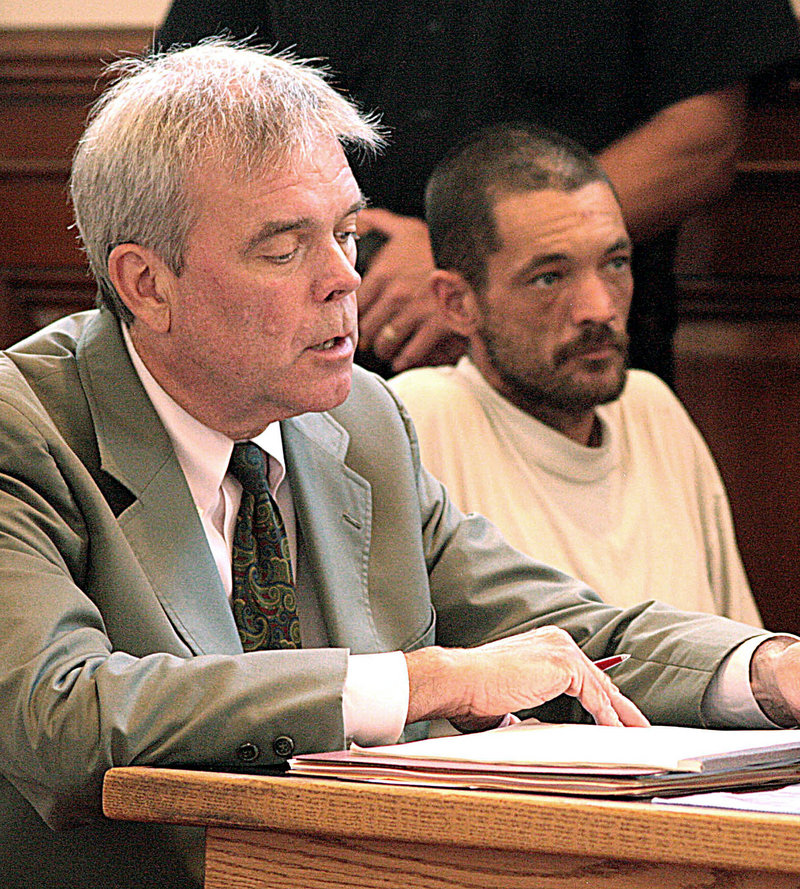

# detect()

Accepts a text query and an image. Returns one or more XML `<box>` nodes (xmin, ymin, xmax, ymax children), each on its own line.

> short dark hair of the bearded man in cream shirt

<box><xmin>425</xmin><ymin>123</ymin><xmax>613</xmax><ymax>292</ymax></box>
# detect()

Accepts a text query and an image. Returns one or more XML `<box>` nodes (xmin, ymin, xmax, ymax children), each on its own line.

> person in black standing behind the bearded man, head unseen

<box><xmin>157</xmin><ymin>0</ymin><xmax>800</xmax><ymax>381</ymax></box>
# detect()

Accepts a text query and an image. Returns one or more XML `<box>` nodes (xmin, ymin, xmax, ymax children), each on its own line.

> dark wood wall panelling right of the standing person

<box><xmin>675</xmin><ymin>63</ymin><xmax>800</xmax><ymax>633</ymax></box>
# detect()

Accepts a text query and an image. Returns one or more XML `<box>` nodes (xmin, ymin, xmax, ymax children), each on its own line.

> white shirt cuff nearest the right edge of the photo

<box><xmin>702</xmin><ymin>634</ymin><xmax>792</xmax><ymax>728</ymax></box>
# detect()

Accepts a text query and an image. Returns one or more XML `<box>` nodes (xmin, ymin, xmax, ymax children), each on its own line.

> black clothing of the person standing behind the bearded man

<box><xmin>159</xmin><ymin>0</ymin><xmax>800</xmax><ymax>379</ymax></box>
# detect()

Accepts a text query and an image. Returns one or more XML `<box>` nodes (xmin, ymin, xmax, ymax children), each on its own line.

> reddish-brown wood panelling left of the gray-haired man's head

<box><xmin>0</xmin><ymin>30</ymin><xmax>149</xmax><ymax>348</ymax></box>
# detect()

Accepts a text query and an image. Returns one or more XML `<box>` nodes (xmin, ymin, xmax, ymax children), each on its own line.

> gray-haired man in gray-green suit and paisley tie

<box><xmin>0</xmin><ymin>43</ymin><xmax>800</xmax><ymax>889</ymax></box>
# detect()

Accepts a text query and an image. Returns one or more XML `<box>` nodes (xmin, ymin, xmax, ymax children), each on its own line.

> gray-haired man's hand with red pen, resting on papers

<box><xmin>406</xmin><ymin>627</ymin><xmax>648</xmax><ymax>730</ymax></box>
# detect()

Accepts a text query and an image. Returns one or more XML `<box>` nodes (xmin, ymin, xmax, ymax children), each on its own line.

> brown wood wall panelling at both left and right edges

<box><xmin>0</xmin><ymin>30</ymin><xmax>800</xmax><ymax>632</ymax></box>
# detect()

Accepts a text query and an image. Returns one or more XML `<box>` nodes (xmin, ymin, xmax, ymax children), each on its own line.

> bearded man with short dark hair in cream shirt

<box><xmin>390</xmin><ymin>125</ymin><xmax>759</xmax><ymax>623</ymax></box>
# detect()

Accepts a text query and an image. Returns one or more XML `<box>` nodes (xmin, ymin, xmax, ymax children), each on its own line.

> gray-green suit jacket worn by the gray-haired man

<box><xmin>0</xmin><ymin>312</ymin><xmax>754</xmax><ymax>889</ymax></box>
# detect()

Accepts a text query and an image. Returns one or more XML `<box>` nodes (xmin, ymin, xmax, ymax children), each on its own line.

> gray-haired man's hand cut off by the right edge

<box><xmin>750</xmin><ymin>636</ymin><xmax>800</xmax><ymax>728</ymax></box>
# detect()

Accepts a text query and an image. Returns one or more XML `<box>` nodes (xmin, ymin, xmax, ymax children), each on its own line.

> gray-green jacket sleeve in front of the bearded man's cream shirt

<box><xmin>333</xmin><ymin>374</ymin><xmax>758</xmax><ymax>725</ymax></box>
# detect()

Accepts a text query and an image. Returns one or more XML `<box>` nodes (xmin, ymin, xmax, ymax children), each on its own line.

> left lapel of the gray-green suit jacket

<box><xmin>76</xmin><ymin>312</ymin><xmax>242</xmax><ymax>654</ymax></box>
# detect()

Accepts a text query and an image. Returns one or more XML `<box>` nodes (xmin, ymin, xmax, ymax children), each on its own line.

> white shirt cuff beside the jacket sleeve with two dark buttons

<box><xmin>342</xmin><ymin>651</ymin><xmax>409</xmax><ymax>747</ymax></box>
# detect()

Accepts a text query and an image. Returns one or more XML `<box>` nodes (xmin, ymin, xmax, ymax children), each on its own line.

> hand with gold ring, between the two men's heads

<box><xmin>358</xmin><ymin>208</ymin><xmax>466</xmax><ymax>373</ymax></box>
